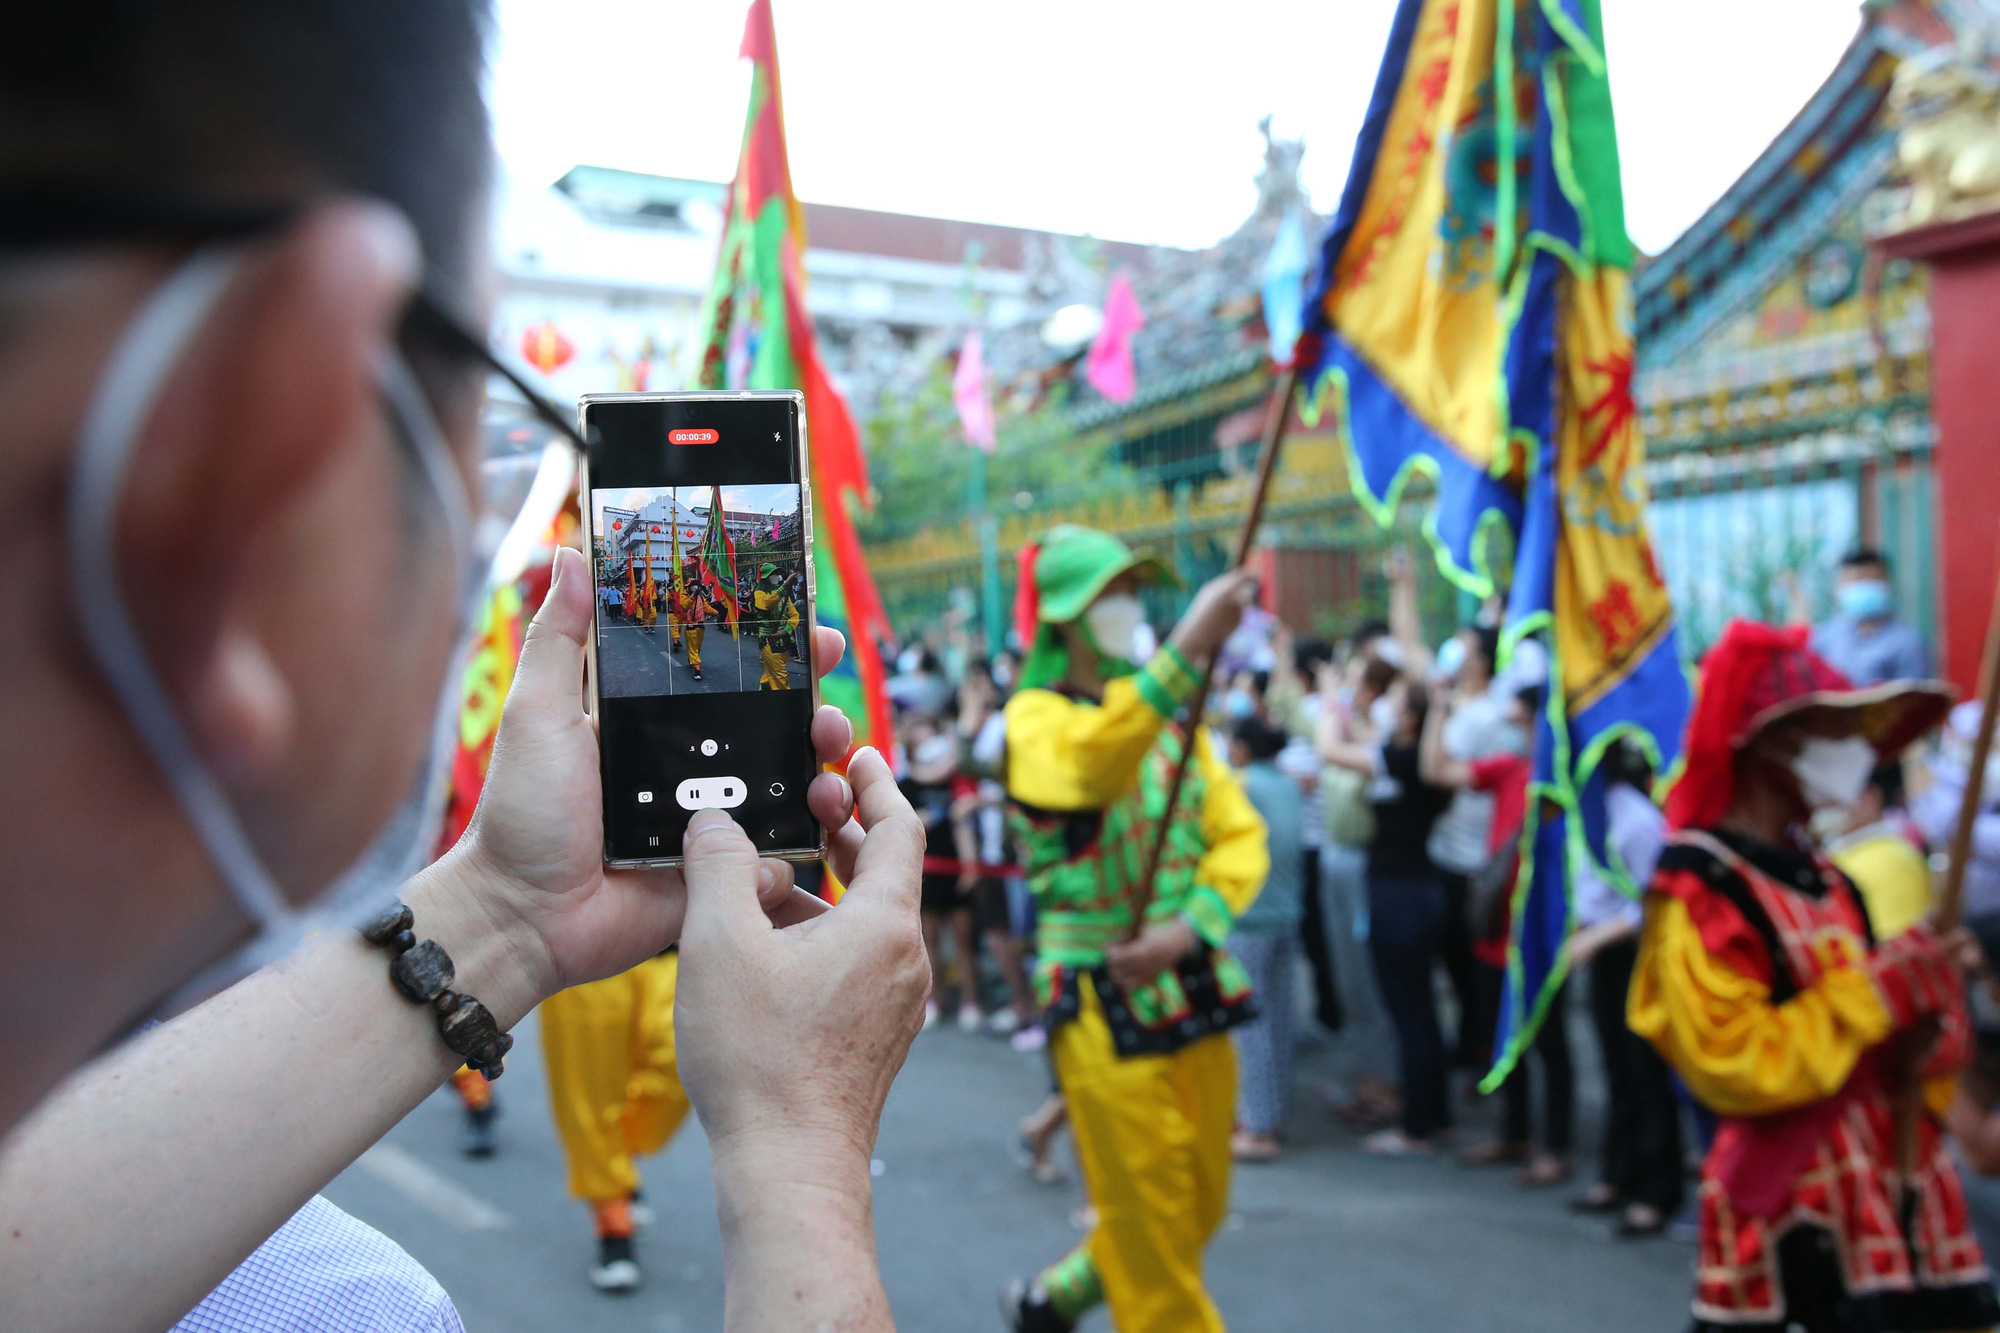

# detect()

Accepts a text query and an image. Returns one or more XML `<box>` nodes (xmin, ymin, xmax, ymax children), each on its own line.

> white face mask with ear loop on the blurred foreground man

<box><xmin>66</xmin><ymin>248</ymin><xmax>484</xmax><ymax>1007</ymax></box>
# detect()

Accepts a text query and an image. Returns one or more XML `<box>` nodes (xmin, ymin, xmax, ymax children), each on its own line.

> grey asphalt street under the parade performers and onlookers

<box><xmin>316</xmin><ymin>992</ymin><xmax>1720</xmax><ymax>1333</ymax></box>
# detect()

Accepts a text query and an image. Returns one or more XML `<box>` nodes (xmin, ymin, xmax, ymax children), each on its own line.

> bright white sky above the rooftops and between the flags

<box><xmin>492</xmin><ymin>0</ymin><xmax>1858</xmax><ymax>250</ymax></box>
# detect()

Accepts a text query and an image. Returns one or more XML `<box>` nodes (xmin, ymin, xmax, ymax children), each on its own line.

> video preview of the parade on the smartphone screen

<box><xmin>590</xmin><ymin>482</ymin><xmax>808</xmax><ymax>699</ymax></box>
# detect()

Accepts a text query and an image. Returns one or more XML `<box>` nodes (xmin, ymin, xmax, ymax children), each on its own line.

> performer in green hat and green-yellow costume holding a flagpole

<box><xmin>1002</xmin><ymin>526</ymin><xmax>1270</xmax><ymax>1333</ymax></box>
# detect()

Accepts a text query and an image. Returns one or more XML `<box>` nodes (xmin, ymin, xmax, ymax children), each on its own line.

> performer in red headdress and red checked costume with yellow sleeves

<box><xmin>1626</xmin><ymin>620</ymin><xmax>2000</xmax><ymax>1333</ymax></box>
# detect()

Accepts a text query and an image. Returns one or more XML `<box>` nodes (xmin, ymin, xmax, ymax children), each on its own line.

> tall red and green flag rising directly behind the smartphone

<box><xmin>700</xmin><ymin>0</ymin><xmax>890</xmax><ymax>747</ymax></box>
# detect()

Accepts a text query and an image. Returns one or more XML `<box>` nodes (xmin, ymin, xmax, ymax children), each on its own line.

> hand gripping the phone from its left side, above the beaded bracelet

<box><xmin>428</xmin><ymin>548</ymin><xmax>854</xmax><ymax>1021</ymax></box>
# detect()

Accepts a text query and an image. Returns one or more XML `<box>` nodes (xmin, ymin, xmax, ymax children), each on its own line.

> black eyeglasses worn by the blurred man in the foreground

<box><xmin>0</xmin><ymin>186</ymin><xmax>590</xmax><ymax>452</ymax></box>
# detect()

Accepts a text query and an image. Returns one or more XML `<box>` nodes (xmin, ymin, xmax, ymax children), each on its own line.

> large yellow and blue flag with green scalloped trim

<box><xmin>1298</xmin><ymin>0</ymin><xmax>1688</xmax><ymax>1081</ymax></box>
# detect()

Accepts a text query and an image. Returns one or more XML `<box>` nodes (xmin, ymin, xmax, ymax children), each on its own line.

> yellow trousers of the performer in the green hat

<box><xmin>1054</xmin><ymin>985</ymin><xmax>1236</xmax><ymax>1333</ymax></box>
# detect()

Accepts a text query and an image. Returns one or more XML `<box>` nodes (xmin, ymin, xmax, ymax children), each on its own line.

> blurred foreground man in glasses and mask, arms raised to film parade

<box><xmin>0</xmin><ymin>0</ymin><xmax>926</xmax><ymax>1333</ymax></box>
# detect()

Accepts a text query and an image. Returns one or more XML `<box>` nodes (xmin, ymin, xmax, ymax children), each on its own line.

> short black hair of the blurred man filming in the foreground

<box><xmin>0</xmin><ymin>0</ymin><xmax>492</xmax><ymax>296</ymax></box>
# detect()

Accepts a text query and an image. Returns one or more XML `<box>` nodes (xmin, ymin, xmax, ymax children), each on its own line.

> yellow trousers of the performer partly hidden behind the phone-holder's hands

<box><xmin>542</xmin><ymin>953</ymin><xmax>688</xmax><ymax>1203</ymax></box>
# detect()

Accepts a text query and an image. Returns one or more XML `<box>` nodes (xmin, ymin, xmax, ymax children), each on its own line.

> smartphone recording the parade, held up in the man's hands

<box><xmin>578</xmin><ymin>392</ymin><xmax>826</xmax><ymax>867</ymax></box>
